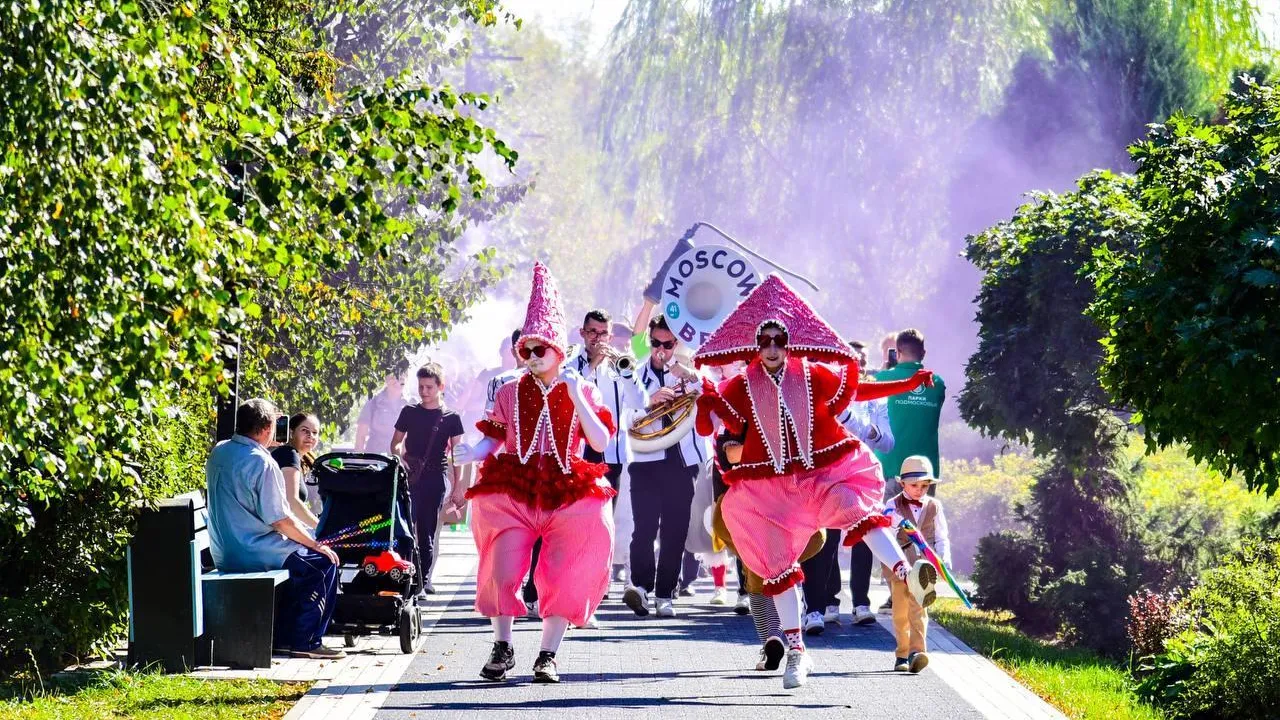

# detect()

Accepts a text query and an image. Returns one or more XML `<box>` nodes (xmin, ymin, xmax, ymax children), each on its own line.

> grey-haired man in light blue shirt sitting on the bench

<box><xmin>205</xmin><ymin>398</ymin><xmax>346</xmax><ymax>659</ymax></box>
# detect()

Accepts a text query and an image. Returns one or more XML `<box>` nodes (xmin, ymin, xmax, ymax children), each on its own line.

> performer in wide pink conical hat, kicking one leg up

<box><xmin>694</xmin><ymin>275</ymin><xmax>937</xmax><ymax>688</ymax></box>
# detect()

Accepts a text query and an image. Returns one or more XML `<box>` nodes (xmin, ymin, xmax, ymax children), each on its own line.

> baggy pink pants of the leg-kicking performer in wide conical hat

<box><xmin>721</xmin><ymin>446</ymin><xmax>884</xmax><ymax>594</ymax></box>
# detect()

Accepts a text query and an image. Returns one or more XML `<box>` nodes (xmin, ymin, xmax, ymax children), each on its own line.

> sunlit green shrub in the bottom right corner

<box><xmin>1139</xmin><ymin>542</ymin><xmax>1280</xmax><ymax>720</ymax></box>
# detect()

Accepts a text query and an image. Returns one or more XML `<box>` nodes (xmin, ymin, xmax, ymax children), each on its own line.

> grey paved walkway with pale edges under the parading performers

<box><xmin>268</xmin><ymin>525</ymin><xmax>1062</xmax><ymax>720</ymax></box>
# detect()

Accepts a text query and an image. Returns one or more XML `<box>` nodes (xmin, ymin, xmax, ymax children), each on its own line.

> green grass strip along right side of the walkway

<box><xmin>929</xmin><ymin>598</ymin><xmax>1164</xmax><ymax>720</ymax></box>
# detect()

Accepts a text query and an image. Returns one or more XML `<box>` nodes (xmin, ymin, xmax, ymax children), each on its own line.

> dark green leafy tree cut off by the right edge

<box><xmin>1089</xmin><ymin>83</ymin><xmax>1280</xmax><ymax>492</ymax></box>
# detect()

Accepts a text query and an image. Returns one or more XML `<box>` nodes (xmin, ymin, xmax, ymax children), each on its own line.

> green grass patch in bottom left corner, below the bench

<box><xmin>0</xmin><ymin>671</ymin><xmax>308</xmax><ymax>720</ymax></box>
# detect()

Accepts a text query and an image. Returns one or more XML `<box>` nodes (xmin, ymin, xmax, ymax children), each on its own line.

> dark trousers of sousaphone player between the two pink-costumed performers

<box><xmin>631</xmin><ymin>457</ymin><xmax>698</xmax><ymax>600</ymax></box>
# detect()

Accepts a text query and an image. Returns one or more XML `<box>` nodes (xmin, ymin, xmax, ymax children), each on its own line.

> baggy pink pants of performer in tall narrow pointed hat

<box><xmin>471</xmin><ymin>493</ymin><xmax>613</xmax><ymax>625</ymax></box>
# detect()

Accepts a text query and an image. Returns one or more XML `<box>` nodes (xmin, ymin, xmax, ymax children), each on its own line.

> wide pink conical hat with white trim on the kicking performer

<box><xmin>694</xmin><ymin>274</ymin><xmax>854</xmax><ymax>366</ymax></box>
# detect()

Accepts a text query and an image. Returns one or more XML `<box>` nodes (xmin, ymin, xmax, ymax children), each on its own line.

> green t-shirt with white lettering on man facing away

<box><xmin>876</xmin><ymin>363</ymin><xmax>947</xmax><ymax>479</ymax></box>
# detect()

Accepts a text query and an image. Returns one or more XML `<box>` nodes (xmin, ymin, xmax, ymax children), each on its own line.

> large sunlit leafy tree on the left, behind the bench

<box><xmin>0</xmin><ymin>0</ymin><xmax>515</xmax><ymax>670</ymax></box>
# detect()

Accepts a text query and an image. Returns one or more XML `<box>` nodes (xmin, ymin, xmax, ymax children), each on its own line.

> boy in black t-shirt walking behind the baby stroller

<box><xmin>392</xmin><ymin>363</ymin><xmax>462</xmax><ymax>593</ymax></box>
